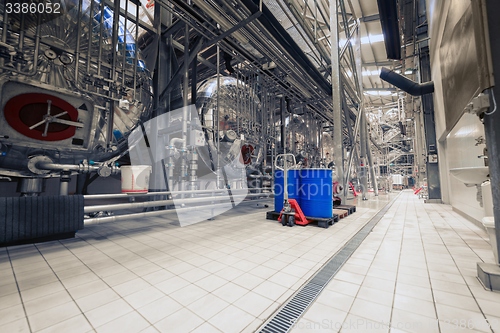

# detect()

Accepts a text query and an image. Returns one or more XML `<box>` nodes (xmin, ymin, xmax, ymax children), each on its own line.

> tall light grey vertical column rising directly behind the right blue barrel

<box><xmin>330</xmin><ymin>0</ymin><xmax>345</xmax><ymax>202</ymax></box>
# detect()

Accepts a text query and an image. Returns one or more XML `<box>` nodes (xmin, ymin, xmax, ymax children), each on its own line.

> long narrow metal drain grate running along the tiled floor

<box><xmin>260</xmin><ymin>197</ymin><xmax>397</xmax><ymax>333</ymax></box>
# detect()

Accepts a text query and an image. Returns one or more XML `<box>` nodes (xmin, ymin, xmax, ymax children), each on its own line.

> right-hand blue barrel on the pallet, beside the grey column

<box><xmin>299</xmin><ymin>169</ymin><xmax>333</xmax><ymax>218</ymax></box>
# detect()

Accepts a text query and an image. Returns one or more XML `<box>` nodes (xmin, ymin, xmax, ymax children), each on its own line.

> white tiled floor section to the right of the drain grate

<box><xmin>292</xmin><ymin>191</ymin><xmax>500</xmax><ymax>333</ymax></box>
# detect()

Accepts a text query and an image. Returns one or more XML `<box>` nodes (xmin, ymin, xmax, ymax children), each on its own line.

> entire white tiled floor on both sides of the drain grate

<box><xmin>0</xmin><ymin>191</ymin><xmax>500</xmax><ymax>333</ymax></box>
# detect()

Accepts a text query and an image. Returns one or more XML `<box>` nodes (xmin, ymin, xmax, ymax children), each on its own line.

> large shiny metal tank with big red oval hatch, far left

<box><xmin>0</xmin><ymin>0</ymin><xmax>152</xmax><ymax>177</ymax></box>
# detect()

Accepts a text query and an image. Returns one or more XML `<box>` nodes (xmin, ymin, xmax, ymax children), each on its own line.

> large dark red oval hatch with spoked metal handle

<box><xmin>4</xmin><ymin>93</ymin><xmax>78</xmax><ymax>141</ymax></box>
